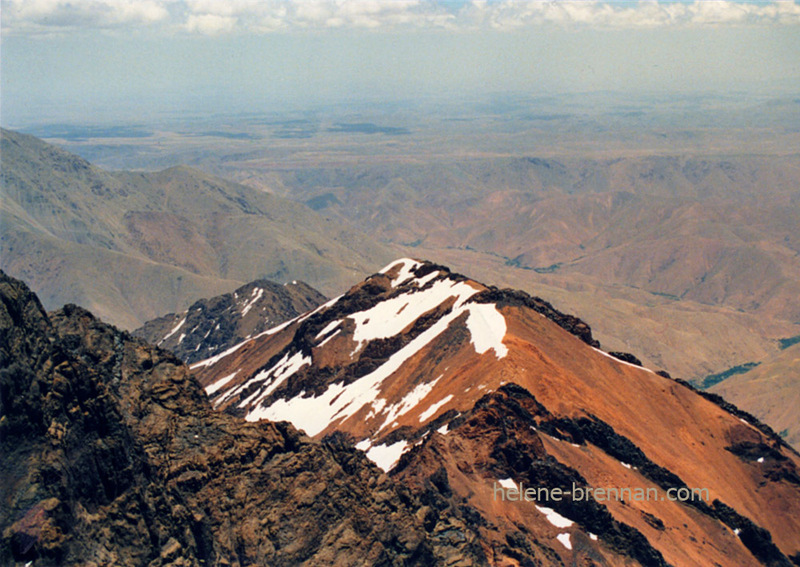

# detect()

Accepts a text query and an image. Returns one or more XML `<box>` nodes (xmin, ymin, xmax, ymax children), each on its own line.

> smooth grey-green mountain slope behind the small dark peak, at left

<box><xmin>0</xmin><ymin>130</ymin><xmax>394</xmax><ymax>329</ymax></box>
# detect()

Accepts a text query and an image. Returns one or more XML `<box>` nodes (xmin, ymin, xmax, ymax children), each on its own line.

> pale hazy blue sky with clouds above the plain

<box><xmin>0</xmin><ymin>0</ymin><xmax>800</xmax><ymax>127</ymax></box>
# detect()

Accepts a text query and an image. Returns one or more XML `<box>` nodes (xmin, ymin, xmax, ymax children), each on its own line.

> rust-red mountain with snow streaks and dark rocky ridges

<box><xmin>191</xmin><ymin>258</ymin><xmax>800</xmax><ymax>566</ymax></box>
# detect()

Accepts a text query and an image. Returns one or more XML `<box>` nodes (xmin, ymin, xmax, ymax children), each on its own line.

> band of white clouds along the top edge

<box><xmin>0</xmin><ymin>0</ymin><xmax>800</xmax><ymax>34</ymax></box>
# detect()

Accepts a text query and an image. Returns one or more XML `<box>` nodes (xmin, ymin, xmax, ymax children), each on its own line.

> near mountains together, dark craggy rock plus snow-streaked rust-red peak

<box><xmin>0</xmin><ymin>259</ymin><xmax>800</xmax><ymax>566</ymax></box>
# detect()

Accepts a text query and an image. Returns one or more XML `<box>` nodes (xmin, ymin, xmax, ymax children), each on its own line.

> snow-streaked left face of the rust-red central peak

<box><xmin>193</xmin><ymin>258</ymin><xmax>520</xmax><ymax>435</ymax></box>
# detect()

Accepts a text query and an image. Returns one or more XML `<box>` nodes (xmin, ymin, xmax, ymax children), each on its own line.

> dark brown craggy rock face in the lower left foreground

<box><xmin>0</xmin><ymin>274</ymin><xmax>486</xmax><ymax>565</ymax></box>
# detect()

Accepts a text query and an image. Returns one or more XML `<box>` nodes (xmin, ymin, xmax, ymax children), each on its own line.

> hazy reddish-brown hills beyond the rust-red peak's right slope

<box><xmin>236</xmin><ymin>153</ymin><xmax>800</xmax><ymax>380</ymax></box>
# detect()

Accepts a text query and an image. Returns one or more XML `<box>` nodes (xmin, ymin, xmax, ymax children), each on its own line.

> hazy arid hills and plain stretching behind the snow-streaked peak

<box><xmin>3</xmin><ymin>95</ymin><xmax>800</xmax><ymax>458</ymax></box>
